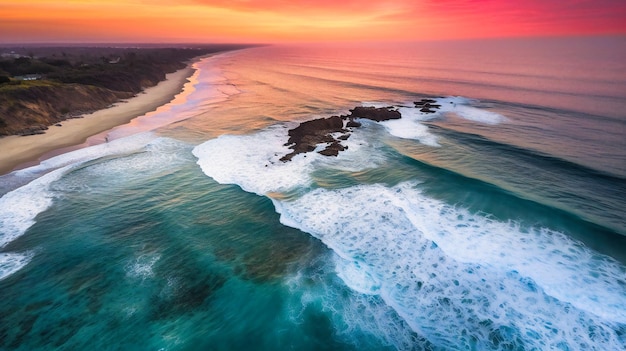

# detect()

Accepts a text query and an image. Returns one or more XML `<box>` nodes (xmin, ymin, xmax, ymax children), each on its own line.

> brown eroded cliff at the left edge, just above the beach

<box><xmin>0</xmin><ymin>81</ymin><xmax>133</xmax><ymax>136</ymax></box>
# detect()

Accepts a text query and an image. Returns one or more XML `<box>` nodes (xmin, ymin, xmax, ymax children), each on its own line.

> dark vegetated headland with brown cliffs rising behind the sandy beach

<box><xmin>0</xmin><ymin>45</ymin><xmax>254</xmax><ymax>136</ymax></box>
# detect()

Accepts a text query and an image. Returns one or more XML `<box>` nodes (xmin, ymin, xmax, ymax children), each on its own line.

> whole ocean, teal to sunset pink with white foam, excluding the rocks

<box><xmin>0</xmin><ymin>37</ymin><xmax>626</xmax><ymax>350</ymax></box>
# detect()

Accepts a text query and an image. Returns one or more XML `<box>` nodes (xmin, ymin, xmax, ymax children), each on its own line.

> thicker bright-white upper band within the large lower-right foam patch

<box><xmin>394</xmin><ymin>192</ymin><xmax>626</xmax><ymax>323</ymax></box>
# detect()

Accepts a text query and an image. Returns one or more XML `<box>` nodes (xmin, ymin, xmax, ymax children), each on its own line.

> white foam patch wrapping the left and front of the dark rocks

<box><xmin>193</xmin><ymin>126</ymin><xmax>382</xmax><ymax>195</ymax></box>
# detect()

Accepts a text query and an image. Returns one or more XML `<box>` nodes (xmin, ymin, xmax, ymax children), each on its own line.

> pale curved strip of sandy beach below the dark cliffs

<box><xmin>0</xmin><ymin>64</ymin><xmax>194</xmax><ymax>174</ymax></box>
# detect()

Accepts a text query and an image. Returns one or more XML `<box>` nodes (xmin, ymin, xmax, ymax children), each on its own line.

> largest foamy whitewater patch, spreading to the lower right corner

<box><xmin>273</xmin><ymin>184</ymin><xmax>626</xmax><ymax>350</ymax></box>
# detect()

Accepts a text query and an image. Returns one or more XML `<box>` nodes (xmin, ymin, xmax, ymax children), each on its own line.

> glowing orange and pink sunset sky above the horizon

<box><xmin>0</xmin><ymin>0</ymin><xmax>626</xmax><ymax>43</ymax></box>
